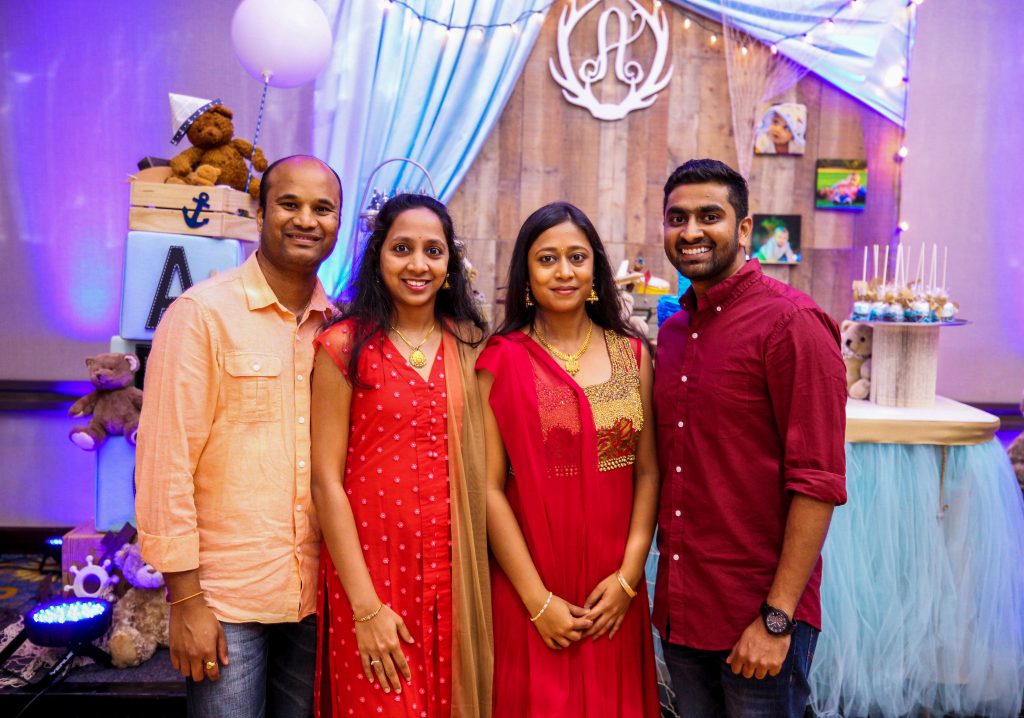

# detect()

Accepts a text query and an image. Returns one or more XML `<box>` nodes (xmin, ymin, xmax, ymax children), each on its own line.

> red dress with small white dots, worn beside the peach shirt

<box><xmin>314</xmin><ymin>320</ymin><xmax>452</xmax><ymax>718</ymax></box>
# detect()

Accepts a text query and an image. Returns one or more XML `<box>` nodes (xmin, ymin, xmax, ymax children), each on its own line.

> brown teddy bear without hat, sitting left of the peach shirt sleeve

<box><xmin>68</xmin><ymin>353</ymin><xmax>142</xmax><ymax>452</ymax></box>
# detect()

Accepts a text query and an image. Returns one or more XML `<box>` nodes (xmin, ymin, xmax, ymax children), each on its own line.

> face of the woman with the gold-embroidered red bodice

<box><xmin>527</xmin><ymin>221</ymin><xmax>594</xmax><ymax>311</ymax></box>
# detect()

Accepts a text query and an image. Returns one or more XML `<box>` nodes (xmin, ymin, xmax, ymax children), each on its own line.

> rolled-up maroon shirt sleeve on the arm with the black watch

<box><xmin>765</xmin><ymin>308</ymin><xmax>846</xmax><ymax>505</ymax></box>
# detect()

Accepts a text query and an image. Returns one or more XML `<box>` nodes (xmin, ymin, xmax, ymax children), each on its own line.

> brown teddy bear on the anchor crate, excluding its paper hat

<box><xmin>166</xmin><ymin>104</ymin><xmax>267</xmax><ymax>199</ymax></box>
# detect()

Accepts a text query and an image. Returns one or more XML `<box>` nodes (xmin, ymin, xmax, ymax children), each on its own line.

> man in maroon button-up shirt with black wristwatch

<box><xmin>654</xmin><ymin>160</ymin><xmax>846</xmax><ymax>718</ymax></box>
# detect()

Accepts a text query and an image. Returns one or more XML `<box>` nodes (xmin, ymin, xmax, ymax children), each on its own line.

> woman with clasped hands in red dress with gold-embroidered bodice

<box><xmin>476</xmin><ymin>203</ymin><xmax>658</xmax><ymax>718</ymax></box>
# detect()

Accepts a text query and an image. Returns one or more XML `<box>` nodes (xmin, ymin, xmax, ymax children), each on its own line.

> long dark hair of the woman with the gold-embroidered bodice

<box><xmin>495</xmin><ymin>202</ymin><xmax>646</xmax><ymax>341</ymax></box>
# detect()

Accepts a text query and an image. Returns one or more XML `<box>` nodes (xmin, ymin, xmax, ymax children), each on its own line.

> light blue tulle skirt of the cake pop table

<box><xmin>811</xmin><ymin>439</ymin><xmax>1024</xmax><ymax>718</ymax></box>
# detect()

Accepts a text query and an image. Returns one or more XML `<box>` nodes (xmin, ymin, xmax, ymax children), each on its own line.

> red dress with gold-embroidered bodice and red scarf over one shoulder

<box><xmin>476</xmin><ymin>331</ymin><xmax>659</xmax><ymax>718</ymax></box>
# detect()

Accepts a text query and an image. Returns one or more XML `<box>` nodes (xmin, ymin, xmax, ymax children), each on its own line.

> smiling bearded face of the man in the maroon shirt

<box><xmin>664</xmin><ymin>182</ymin><xmax>753</xmax><ymax>295</ymax></box>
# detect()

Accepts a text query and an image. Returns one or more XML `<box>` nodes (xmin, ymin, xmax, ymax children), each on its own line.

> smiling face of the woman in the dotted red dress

<box><xmin>380</xmin><ymin>207</ymin><xmax>449</xmax><ymax>311</ymax></box>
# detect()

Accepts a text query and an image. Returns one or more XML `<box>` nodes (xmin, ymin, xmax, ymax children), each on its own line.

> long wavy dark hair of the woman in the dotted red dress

<box><xmin>328</xmin><ymin>194</ymin><xmax>486</xmax><ymax>388</ymax></box>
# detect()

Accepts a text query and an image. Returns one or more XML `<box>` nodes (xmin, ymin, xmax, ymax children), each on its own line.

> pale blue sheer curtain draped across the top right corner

<box><xmin>672</xmin><ymin>0</ymin><xmax>913</xmax><ymax>125</ymax></box>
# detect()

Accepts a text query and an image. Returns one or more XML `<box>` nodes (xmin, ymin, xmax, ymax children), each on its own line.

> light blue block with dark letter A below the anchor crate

<box><xmin>118</xmin><ymin>231</ymin><xmax>244</xmax><ymax>340</ymax></box>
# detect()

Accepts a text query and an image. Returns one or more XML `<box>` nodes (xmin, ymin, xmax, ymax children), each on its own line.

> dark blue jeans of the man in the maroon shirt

<box><xmin>663</xmin><ymin>622</ymin><xmax>818</xmax><ymax>718</ymax></box>
